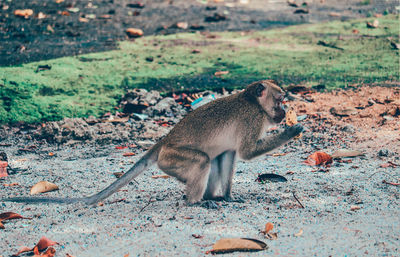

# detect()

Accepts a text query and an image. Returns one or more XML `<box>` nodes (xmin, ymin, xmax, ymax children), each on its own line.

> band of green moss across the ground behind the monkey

<box><xmin>0</xmin><ymin>15</ymin><xmax>400</xmax><ymax>123</ymax></box>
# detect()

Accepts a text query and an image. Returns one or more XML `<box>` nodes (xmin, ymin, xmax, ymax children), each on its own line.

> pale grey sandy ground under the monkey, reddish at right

<box><xmin>0</xmin><ymin>85</ymin><xmax>400</xmax><ymax>256</ymax></box>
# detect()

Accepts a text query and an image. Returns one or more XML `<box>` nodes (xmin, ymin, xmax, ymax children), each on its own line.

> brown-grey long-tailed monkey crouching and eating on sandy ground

<box><xmin>1</xmin><ymin>80</ymin><xmax>303</xmax><ymax>205</ymax></box>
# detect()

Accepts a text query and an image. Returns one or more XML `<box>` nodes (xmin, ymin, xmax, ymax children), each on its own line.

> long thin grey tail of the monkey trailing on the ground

<box><xmin>0</xmin><ymin>144</ymin><xmax>160</xmax><ymax>204</ymax></box>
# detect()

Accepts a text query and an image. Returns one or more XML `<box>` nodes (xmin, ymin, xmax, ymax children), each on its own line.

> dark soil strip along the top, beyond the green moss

<box><xmin>0</xmin><ymin>0</ymin><xmax>397</xmax><ymax>66</ymax></box>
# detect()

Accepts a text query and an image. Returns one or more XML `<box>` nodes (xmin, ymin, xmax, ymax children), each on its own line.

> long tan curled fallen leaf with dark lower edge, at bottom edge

<box><xmin>211</xmin><ymin>238</ymin><xmax>267</xmax><ymax>253</ymax></box>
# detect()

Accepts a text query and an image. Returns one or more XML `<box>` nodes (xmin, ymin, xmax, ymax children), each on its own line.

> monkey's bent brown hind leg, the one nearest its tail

<box><xmin>158</xmin><ymin>145</ymin><xmax>210</xmax><ymax>204</ymax></box>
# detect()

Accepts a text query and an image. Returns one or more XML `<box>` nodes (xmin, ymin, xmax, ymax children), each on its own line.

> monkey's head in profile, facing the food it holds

<box><xmin>246</xmin><ymin>80</ymin><xmax>286</xmax><ymax>123</ymax></box>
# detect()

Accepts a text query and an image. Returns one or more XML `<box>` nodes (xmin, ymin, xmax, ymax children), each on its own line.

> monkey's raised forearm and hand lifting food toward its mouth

<box><xmin>239</xmin><ymin>124</ymin><xmax>304</xmax><ymax>160</ymax></box>
